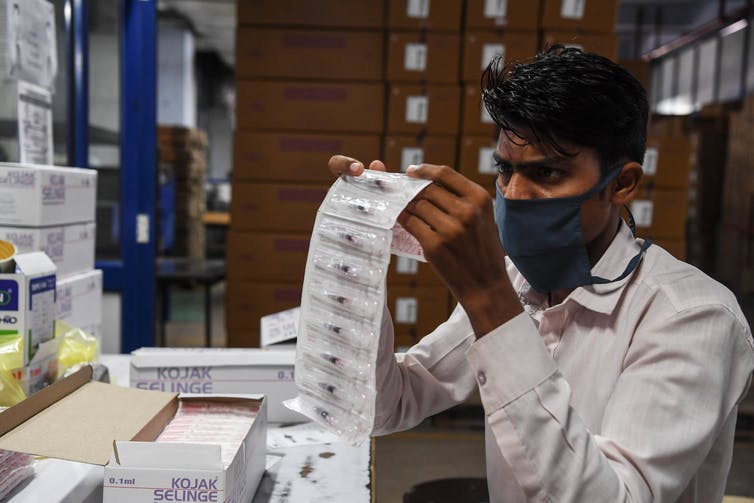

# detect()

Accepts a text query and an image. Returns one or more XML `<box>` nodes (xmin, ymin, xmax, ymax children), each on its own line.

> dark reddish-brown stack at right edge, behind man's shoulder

<box><xmin>718</xmin><ymin>95</ymin><xmax>754</xmax><ymax>294</ymax></box>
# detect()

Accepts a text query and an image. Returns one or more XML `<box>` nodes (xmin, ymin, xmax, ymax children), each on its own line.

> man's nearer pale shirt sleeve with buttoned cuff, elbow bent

<box><xmin>467</xmin><ymin>306</ymin><xmax>754</xmax><ymax>502</ymax></box>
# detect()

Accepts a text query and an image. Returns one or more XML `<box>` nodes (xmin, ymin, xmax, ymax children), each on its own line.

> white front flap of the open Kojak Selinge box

<box><xmin>111</xmin><ymin>441</ymin><xmax>223</xmax><ymax>470</ymax></box>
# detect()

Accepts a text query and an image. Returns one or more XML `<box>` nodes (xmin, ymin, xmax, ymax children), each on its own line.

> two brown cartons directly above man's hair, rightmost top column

<box><xmin>542</xmin><ymin>0</ymin><xmax>619</xmax><ymax>61</ymax></box>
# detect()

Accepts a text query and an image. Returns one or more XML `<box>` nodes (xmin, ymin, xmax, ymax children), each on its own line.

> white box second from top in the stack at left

<box><xmin>0</xmin><ymin>222</ymin><xmax>96</xmax><ymax>278</ymax></box>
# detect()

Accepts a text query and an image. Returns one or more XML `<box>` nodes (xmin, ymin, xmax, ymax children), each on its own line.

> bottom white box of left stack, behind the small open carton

<box><xmin>55</xmin><ymin>269</ymin><xmax>102</xmax><ymax>345</ymax></box>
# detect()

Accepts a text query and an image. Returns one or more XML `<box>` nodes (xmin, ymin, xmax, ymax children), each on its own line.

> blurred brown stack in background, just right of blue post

<box><xmin>157</xmin><ymin>126</ymin><xmax>208</xmax><ymax>258</ymax></box>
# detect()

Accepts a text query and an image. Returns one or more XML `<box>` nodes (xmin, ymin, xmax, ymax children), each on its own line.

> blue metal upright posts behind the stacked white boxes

<box><xmin>66</xmin><ymin>0</ymin><xmax>157</xmax><ymax>352</ymax></box>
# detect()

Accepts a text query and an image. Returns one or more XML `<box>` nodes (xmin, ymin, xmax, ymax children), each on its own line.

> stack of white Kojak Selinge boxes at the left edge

<box><xmin>0</xmin><ymin>163</ymin><xmax>102</xmax><ymax>386</ymax></box>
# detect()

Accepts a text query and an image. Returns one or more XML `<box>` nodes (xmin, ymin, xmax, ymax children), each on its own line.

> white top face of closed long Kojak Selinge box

<box><xmin>131</xmin><ymin>348</ymin><xmax>296</xmax><ymax>368</ymax></box>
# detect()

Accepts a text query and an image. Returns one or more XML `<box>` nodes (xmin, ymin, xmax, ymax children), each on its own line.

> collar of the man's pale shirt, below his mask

<box><xmin>505</xmin><ymin>221</ymin><xmax>642</xmax><ymax>314</ymax></box>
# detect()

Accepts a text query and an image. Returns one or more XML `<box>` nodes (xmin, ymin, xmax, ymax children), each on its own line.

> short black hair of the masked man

<box><xmin>482</xmin><ymin>45</ymin><xmax>648</xmax><ymax>171</ymax></box>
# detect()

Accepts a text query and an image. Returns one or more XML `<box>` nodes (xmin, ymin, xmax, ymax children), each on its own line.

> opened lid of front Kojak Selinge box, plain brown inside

<box><xmin>0</xmin><ymin>366</ymin><xmax>178</xmax><ymax>465</ymax></box>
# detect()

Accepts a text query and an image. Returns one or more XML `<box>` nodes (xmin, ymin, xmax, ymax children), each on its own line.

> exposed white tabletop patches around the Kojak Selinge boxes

<box><xmin>5</xmin><ymin>355</ymin><xmax>372</xmax><ymax>503</ymax></box>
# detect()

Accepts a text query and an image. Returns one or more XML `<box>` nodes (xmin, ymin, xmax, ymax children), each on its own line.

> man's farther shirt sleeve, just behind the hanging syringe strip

<box><xmin>372</xmin><ymin>307</ymin><xmax>476</xmax><ymax>435</ymax></box>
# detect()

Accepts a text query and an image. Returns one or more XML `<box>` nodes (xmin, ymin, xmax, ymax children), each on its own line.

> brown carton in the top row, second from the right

<box><xmin>466</xmin><ymin>0</ymin><xmax>542</xmax><ymax>31</ymax></box>
